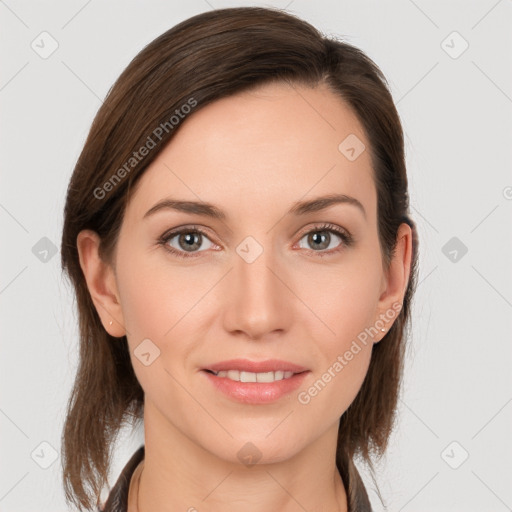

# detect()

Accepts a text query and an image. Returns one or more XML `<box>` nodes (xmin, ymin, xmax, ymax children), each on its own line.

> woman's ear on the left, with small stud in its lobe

<box><xmin>77</xmin><ymin>229</ymin><xmax>126</xmax><ymax>338</ymax></box>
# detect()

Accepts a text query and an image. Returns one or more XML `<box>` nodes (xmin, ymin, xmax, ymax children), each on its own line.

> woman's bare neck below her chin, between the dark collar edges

<box><xmin>135</xmin><ymin>403</ymin><xmax>347</xmax><ymax>512</ymax></box>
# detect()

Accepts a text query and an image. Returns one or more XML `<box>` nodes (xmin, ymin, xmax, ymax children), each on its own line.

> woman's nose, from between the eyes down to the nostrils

<box><xmin>223</xmin><ymin>240</ymin><xmax>293</xmax><ymax>340</ymax></box>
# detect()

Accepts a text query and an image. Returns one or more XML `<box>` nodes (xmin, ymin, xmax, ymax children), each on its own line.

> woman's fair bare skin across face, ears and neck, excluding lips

<box><xmin>77</xmin><ymin>83</ymin><xmax>412</xmax><ymax>512</ymax></box>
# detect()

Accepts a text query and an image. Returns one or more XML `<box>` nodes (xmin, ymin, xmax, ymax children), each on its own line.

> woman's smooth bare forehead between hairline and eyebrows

<box><xmin>127</xmin><ymin>83</ymin><xmax>376</xmax><ymax>226</ymax></box>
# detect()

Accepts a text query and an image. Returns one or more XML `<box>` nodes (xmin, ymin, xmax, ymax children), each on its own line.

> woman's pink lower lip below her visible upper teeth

<box><xmin>202</xmin><ymin>370</ymin><xmax>309</xmax><ymax>404</ymax></box>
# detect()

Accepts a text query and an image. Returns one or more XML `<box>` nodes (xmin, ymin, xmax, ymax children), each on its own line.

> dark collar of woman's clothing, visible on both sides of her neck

<box><xmin>98</xmin><ymin>445</ymin><xmax>372</xmax><ymax>512</ymax></box>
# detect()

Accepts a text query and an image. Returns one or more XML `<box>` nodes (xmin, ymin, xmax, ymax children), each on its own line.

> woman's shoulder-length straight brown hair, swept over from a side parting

<box><xmin>61</xmin><ymin>7</ymin><xmax>418</xmax><ymax>510</ymax></box>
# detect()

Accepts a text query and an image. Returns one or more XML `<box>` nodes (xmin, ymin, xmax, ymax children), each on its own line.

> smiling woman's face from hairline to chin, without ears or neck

<box><xmin>95</xmin><ymin>80</ymin><xmax>404</xmax><ymax>462</ymax></box>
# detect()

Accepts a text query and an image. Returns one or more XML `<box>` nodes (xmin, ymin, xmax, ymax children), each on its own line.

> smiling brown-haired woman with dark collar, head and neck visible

<box><xmin>62</xmin><ymin>7</ymin><xmax>418</xmax><ymax>512</ymax></box>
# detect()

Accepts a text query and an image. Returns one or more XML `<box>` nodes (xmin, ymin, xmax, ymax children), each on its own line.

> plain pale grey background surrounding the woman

<box><xmin>0</xmin><ymin>0</ymin><xmax>512</xmax><ymax>512</ymax></box>
